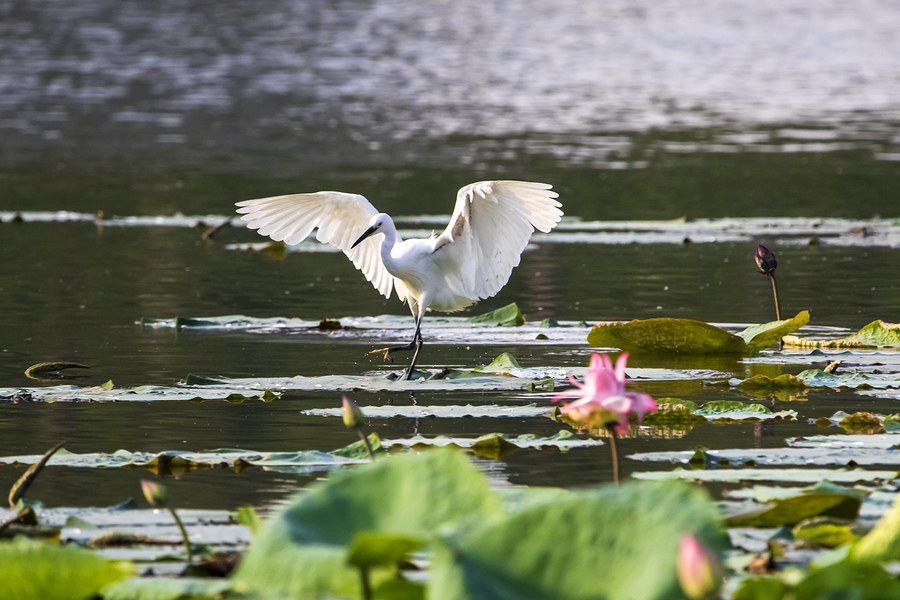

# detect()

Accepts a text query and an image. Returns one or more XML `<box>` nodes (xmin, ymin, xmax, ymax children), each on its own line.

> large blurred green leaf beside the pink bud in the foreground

<box><xmin>429</xmin><ymin>482</ymin><xmax>726</xmax><ymax>600</ymax></box>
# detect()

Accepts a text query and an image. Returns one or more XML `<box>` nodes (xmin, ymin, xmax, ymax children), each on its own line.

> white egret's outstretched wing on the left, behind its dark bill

<box><xmin>237</xmin><ymin>192</ymin><xmax>404</xmax><ymax>300</ymax></box>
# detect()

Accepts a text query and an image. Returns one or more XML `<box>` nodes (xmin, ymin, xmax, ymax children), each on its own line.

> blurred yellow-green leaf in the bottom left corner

<box><xmin>0</xmin><ymin>538</ymin><xmax>132</xmax><ymax>600</ymax></box>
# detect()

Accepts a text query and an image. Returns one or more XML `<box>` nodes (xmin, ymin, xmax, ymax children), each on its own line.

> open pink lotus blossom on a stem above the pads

<box><xmin>553</xmin><ymin>352</ymin><xmax>656</xmax><ymax>433</ymax></box>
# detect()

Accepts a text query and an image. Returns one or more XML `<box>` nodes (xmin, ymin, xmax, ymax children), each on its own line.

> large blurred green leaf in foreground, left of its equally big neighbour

<box><xmin>236</xmin><ymin>449</ymin><xmax>501</xmax><ymax>598</ymax></box>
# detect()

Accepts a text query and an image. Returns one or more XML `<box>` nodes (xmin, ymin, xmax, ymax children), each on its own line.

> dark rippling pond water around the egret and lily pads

<box><xmin>0</xmin><ymin>0</ymin><xmax>900</xmax><ymax>508</ymax></box>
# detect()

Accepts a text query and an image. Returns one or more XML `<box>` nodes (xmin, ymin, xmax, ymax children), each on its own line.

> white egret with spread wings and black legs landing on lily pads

<box><xmin>237</xmin><ymin>181</ymin><xmax>563</xmax><ymax>379</ymax></box>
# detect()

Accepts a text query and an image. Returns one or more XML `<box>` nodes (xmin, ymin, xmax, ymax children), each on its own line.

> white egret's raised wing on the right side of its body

<box><xmin>434</xmin><ymin>181</ymin><xmax>563</xmax><ymax>300</ymax></box>
